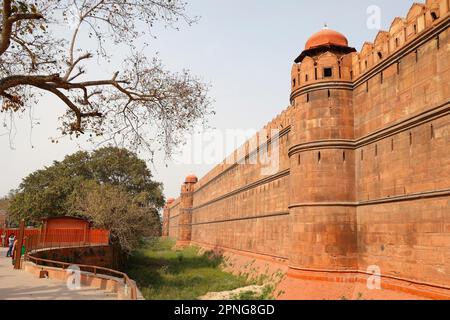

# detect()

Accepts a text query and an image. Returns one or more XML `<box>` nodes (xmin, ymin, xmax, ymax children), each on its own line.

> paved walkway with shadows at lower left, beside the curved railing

<box><xmin>0</xmin><ymin>248</ymin><xmax>116</xmax><ymax>300</ymax></box>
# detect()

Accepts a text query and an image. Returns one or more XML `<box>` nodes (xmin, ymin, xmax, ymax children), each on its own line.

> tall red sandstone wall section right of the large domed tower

<box><xmin>354</xmin><ymin>12</ymin><xmax>450</xmax><ymax>285</ymax></box>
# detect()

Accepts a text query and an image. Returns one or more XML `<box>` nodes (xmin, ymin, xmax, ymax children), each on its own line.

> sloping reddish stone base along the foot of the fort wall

<box><xmin>185</xmin><ymin>241</ymin><xmax>450</xmax><ymax>300</ymax></box>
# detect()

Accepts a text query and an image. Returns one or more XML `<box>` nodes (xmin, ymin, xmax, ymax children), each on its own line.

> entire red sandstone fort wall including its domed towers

<box><xmin>163</xmin><ymin>0</ymin><xmax>450</xmax><ymax>298</ymax></box>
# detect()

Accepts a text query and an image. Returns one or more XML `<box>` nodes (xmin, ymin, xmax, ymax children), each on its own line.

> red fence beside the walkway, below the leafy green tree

<box><xmin>0</xmin><ymin>229</ymin><xmax>109</xmax><ymax>251</ymax></box>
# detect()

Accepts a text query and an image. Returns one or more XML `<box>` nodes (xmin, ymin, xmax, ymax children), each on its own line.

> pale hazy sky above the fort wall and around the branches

<box><xmin>0</xmin><ymin>0</ymin><xmax>413</xmax><ymax>197</ymax></box>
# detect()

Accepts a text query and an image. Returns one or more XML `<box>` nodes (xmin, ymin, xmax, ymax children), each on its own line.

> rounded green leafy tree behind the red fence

<box><xmin>9</xmin><ymin>147</ymin><xmax>164</xmax><ymax>236</ymax></box>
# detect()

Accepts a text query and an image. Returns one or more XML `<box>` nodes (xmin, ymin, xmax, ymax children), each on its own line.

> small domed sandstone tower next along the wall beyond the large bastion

<box><xmin>177</xmin><ymin>175</ymin><xmax>198</xmax><ymax>246</ymax></box>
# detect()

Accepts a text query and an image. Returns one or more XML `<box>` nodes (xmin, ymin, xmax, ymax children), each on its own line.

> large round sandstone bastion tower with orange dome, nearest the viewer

<box><xmin>289</xmin><ymin>27</ymin><xmax>358</xmax><ymax>273</ymax></box>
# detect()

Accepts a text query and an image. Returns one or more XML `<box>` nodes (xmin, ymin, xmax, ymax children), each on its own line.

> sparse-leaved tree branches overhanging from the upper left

<box><xmin>0</xmin><ymin>0</ymin><xmax>211</xmax><ymax>155</ymax></box>
